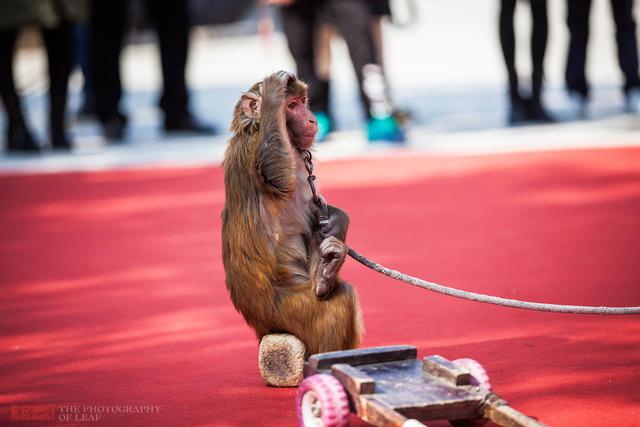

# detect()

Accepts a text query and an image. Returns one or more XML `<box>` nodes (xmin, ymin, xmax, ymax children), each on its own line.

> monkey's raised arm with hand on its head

<box><xmin>256</xmin><ymin>71</ymin><xmax>296</xmax><ymax>195</ymax></box>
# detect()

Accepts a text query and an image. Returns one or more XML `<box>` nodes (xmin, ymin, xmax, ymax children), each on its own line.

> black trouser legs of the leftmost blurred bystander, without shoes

<box><xmin>0</xmin><ymin>22</ymin><xmax>73</xmax><ymax>141</ymax></box>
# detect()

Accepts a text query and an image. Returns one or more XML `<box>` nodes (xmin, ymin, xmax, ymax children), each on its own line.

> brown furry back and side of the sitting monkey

<box><xmin>222</xmin><ymin>139</ymin><xmax>317</xmax><ymax>327</ymax></box>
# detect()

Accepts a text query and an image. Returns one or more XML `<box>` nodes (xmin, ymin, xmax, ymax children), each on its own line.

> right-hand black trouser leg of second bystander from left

<box><xmin>145</xmin><ymin>0</ymin><xmax>190</xmax><ymax>122</ymax></box>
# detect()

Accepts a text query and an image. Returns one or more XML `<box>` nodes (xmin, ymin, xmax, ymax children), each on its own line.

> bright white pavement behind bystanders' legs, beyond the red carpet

<box><xmin>0</xmin><ymin>0</ymin><xmax>640</xmax><ymax>173</ymax></box>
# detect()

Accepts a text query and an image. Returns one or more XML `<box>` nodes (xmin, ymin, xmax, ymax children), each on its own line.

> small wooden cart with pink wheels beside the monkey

<box><xmin>296</xmin><ymin>346</ymin><xmax>544</xmax><ymax>427</ymax></box>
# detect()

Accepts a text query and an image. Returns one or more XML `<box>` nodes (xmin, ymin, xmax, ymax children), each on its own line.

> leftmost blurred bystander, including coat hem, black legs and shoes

<box><xmin>0</xmin><ymin>0</ymin><xmax>79</xmax><ymax>153</ymax></box>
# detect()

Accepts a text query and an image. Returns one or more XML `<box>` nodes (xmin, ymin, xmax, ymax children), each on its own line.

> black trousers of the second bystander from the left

<box><xmin>90</xmin><ymin>0</ymin><xmax>189</xmax><ymax>122</ymax></box>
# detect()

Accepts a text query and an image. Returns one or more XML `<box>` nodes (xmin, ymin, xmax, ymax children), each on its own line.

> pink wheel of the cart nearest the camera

<box><xmin>296</xmin><ymin>374</ymin><xmax>349</xmax><ymax>427</ymax></box>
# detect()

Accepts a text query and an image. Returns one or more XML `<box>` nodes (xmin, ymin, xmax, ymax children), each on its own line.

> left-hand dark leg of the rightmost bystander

<box><xmin>565</xmin><ymin>0</ymin><xmax>591</xmax><ymax>98</ymax></box>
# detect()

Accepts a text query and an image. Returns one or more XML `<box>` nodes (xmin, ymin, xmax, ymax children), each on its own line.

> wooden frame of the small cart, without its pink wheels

<box><xmin>304</xmin><ymin>346</ymin><xmax>544</xmax><ymax>427</ymax></box>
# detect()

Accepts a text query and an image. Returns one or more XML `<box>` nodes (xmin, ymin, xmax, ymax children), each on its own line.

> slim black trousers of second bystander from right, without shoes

<box><xmin>499</xmin><ymin>0</ymin><xmax>548</xmax><ymax>101</ymax></box>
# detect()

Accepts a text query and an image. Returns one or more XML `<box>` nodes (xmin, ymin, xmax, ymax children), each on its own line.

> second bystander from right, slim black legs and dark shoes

<box><xmin>499</xmin><ymin>0</ymin><xmax>553</xmax><ymax>124</ymax></box>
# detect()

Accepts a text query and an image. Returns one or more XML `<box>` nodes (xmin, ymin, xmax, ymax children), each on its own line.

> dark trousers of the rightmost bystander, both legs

<box><xmin>565</xmin><ymin>0</ymin><xmax>640</xmax><ymax>97</ymax></box>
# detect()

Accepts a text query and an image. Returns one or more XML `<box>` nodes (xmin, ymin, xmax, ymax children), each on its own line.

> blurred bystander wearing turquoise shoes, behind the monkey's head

<box><xmin>267</xmin><ymin>0</ymin><xmax>404</xmax><ymax>142</ymax></box>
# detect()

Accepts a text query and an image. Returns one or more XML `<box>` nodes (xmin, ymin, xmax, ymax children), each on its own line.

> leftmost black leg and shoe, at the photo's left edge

<box><xmin>0</xmin><ymin>30</ymin><xmax>39</xmax><ymax>151</ymax></box>
